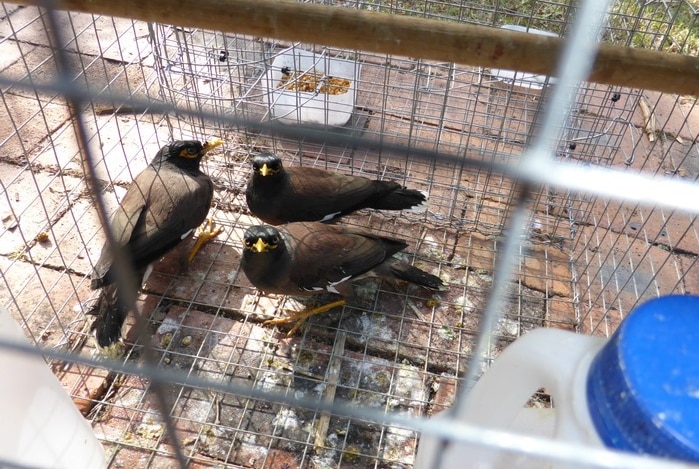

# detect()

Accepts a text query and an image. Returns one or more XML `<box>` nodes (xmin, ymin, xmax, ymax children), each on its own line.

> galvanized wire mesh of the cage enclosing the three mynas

<box><xmin>0</xmin><ymin>1</ymin><xmax>699</xmax><ymax>468</ymax></box>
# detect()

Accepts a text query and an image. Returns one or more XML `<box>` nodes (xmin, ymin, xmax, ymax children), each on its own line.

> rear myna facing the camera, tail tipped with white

<box><xmin>245</xmin><ymin>153</ymin><xmax>426</xmax><ymax>225</ymax></box>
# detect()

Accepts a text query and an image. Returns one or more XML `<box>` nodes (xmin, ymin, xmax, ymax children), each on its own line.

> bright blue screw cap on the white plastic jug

<box><xmin>587</xmin><ymin>295</ymin><xmax>699</xmax><ymax>462</ymax></box>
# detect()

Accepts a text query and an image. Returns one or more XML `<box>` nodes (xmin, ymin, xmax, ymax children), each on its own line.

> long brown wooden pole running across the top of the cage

<box><xmin>15</xmin><ymin>0</ymin><xmax>699</xmax><ymax>96</ymax></box>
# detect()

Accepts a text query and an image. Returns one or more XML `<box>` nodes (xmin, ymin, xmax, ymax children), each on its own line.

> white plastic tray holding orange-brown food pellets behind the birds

<box><xmin>264</xmin><ymin>47</ymin><xmax>360</xmax><ymax>126</ymax></box>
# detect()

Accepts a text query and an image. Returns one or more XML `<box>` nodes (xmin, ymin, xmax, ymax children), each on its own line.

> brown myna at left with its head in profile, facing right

<box><xmin>91</xmin><ymin>140</ymin><xmax>223</xmax><ymax>353</ymax></box>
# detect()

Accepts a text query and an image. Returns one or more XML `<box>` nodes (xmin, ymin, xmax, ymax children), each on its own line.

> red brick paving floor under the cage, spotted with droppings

<box><xmin>0</xmin><ymin>6</ymin><xmax>699</xmax><ymax>468</ymax></box>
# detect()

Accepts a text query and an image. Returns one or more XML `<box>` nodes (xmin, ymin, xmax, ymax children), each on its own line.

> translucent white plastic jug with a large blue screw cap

<box><xmin>414</xmin><ymin>295</ymin><xmax>699</xmax><ymax>469</ymax></box>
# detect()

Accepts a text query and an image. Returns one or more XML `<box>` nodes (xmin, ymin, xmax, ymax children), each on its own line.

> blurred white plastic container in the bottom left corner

<box><xmin>0</xmin><ymin>308</ymin><xmax>105</xmax><ymax>469</ymax></box>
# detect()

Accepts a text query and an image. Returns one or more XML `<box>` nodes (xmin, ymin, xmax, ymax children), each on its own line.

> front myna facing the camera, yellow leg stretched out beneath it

<box><xmin>242</xmin><ymin>222</ymin><xmax>444</xmax><ymax>334</ymax></box>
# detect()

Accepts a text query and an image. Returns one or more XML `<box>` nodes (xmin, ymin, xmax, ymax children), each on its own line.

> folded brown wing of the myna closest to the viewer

<box><xmin>285</xmin><ymin>223</ymin><xmax>393</xmax><ymax>291</ymax></box>
